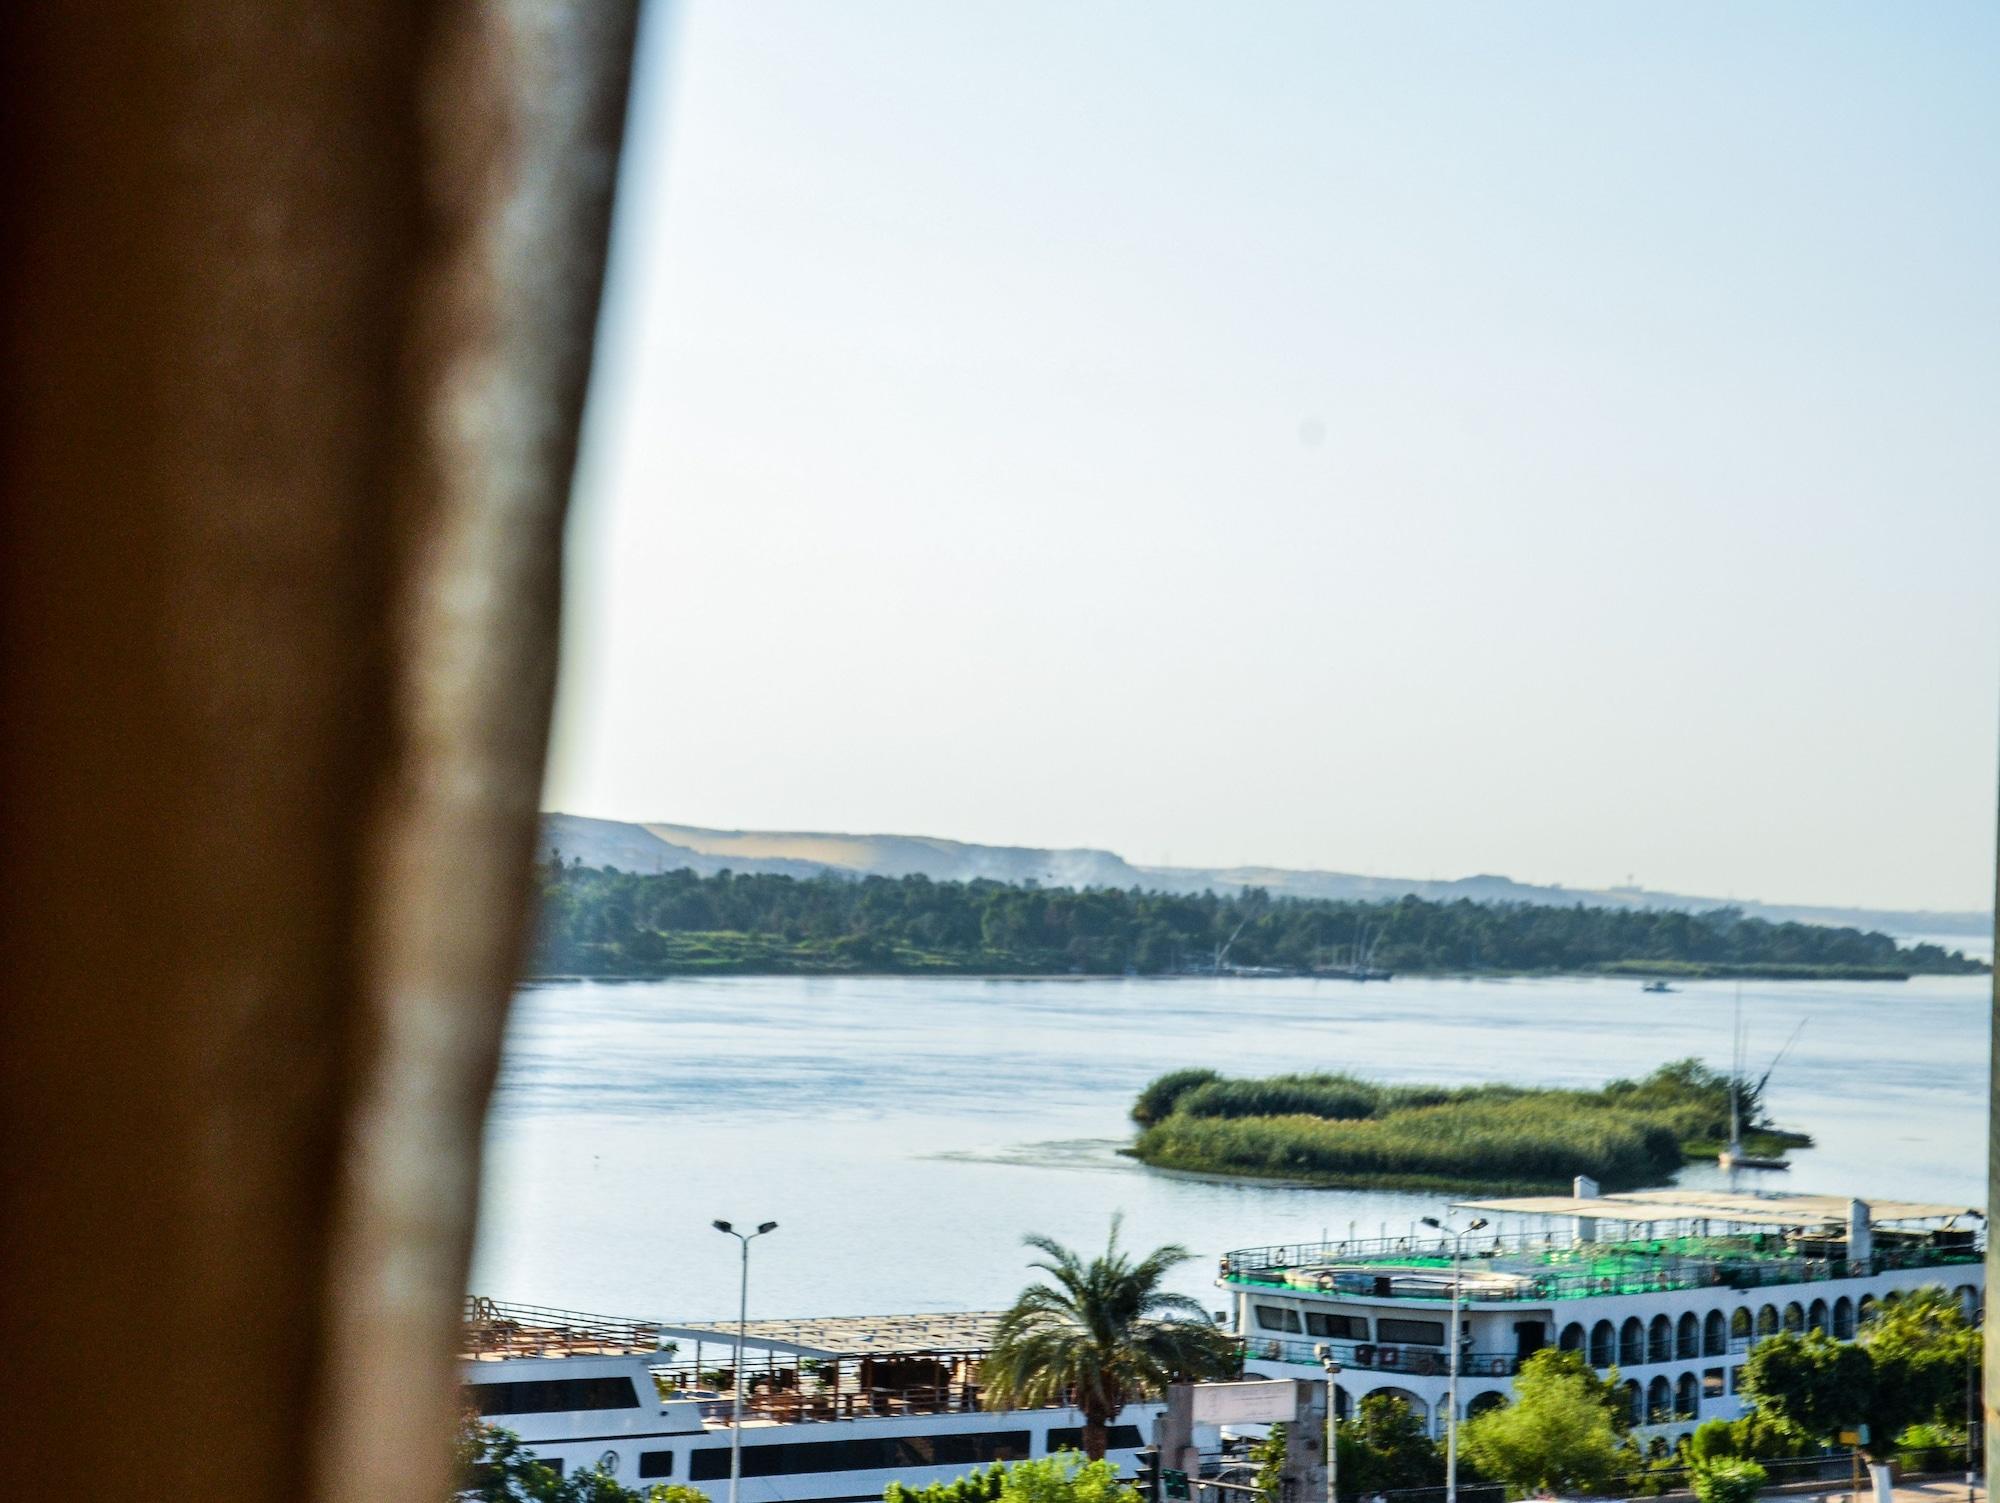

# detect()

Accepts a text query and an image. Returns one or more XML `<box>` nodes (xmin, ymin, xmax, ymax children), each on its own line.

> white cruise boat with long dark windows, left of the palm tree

<box><xmin>460</xmin><ymin>1299</ymin><xmax>1214</xmax><ymax>1503</ymax></box>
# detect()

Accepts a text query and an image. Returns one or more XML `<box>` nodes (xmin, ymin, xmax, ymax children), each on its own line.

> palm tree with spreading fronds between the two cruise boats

<box><xmin>980</xmin><ymin>1217</ymin><xmax>1242</xmax><ymax>1461</ymax></box>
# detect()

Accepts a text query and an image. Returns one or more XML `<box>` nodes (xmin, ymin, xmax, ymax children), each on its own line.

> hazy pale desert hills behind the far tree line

<box><xmin>542</xmin><ymin>813</ymin><xmax>1992</xmax><ymax>937</ymax></box>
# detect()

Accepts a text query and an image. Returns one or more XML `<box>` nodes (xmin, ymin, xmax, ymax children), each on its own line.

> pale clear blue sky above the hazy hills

<box><xmin>546</xmin><ymin>0</ymin><xmax>2000</xmax><ymax>907</ymax></box>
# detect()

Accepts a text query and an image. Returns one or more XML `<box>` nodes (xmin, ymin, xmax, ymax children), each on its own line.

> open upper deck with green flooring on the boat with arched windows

<box><xmin>1222</xmin><ymin>1191</ymin><xmax>1984</xmax><ymax>1301</ymax></box>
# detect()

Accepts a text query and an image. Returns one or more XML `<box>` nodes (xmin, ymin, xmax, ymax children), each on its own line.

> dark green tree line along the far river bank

<box><xmin>530</xmin><ymin>851</ymin><xmax>1986</xmax><ymax>977</ymax></box>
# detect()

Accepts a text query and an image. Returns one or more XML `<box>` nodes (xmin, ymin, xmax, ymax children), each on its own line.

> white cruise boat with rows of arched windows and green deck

<box><xmin>1218</xmin><ymin>1181</ymin><xmax>1986</xmax><ymax>1437</ymax></box>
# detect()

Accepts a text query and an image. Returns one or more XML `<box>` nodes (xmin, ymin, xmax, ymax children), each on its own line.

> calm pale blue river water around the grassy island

<box><xmin>474</xmin><ymin>977</ymin><xmax>1988</xmax><ymax>1319</ymax></box>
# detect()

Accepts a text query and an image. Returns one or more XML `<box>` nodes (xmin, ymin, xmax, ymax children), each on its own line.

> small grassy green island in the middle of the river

<box><xmin>1130</xmin><ymin>1059</ymin><xmax>1812</xmax><ymax>1193</ymax></box>
